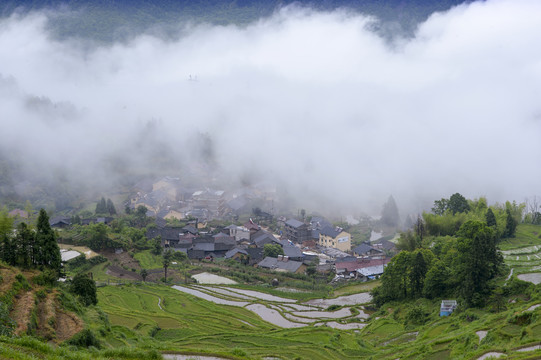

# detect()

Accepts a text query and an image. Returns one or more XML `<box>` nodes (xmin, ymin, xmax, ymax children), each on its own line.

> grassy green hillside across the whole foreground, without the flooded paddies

<box><xmin>0</xmin><ymin>225</ymin><xmax>541</xmax><ymax>359</ymax></box>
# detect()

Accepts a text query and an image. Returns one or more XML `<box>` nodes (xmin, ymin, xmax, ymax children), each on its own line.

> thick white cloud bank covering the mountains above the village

<box><xmin>0</xmin><ymin>0</ymin><xmax>541</xmax><ymax>214</ymax></box>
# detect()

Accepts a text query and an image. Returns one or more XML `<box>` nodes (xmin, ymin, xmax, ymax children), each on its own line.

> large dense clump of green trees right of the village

<box><xmin>372</xmin><ymin>193</ymin><xmax>524</xmax><ymax>307</ymax></box>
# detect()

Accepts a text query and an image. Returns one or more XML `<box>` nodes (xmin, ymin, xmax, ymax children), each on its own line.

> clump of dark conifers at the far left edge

<box><xmin>0</xmin><ymin>209</ymin><xmax>62</xmax><ymax>275</ymax></box>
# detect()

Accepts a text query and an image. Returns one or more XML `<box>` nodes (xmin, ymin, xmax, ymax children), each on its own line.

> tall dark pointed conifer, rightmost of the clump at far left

<box><xmin>34</xmin><ymin>209</ymin><xmax>62</xmax><ymax>274</ymax></box>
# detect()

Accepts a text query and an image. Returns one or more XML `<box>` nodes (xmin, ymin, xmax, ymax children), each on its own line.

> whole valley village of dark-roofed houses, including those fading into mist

<box><xmin>45</xmin><ymin>177</ymin><xmax>396</xmax><ymax>281</ymax></box>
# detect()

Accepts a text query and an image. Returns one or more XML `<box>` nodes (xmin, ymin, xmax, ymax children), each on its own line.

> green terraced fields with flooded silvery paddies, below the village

<box><xmin>99</xmin><ymin>284</ymin><xmax>541</xmax><ymax>360</ymax></box>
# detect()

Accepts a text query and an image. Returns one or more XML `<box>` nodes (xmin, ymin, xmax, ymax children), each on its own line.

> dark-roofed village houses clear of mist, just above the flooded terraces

<box><xmin>147</xmin><ymin>214</ymin><xmax>394</xmax><ymax>280</ymax></box>
